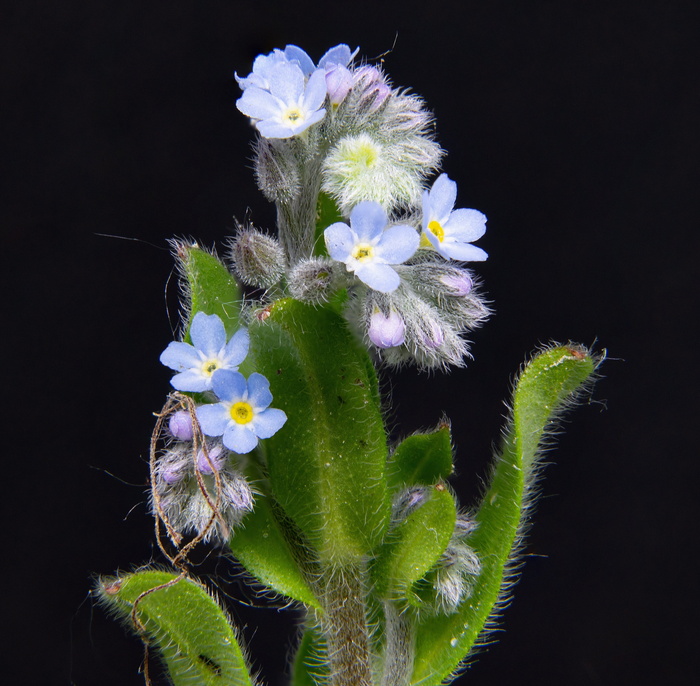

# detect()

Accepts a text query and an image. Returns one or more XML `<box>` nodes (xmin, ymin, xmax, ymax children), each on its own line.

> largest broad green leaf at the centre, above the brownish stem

<box><xmin>249</xmin><ymin>299</ymin><xmax>390</xmax><ymax>563</ymax></box>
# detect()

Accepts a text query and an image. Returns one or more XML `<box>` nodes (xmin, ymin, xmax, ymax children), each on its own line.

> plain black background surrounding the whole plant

<box><xmin>0</xmin><ymin>0</ymin><xmax>700</xmax><ymax>686</ymax></box>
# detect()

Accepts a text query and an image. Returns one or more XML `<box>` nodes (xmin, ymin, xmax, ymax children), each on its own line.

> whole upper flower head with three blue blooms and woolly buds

<box><xmin>230</xmin><ymin>45</ymin><xmax>489</xmax><ymax>369</ymax></box>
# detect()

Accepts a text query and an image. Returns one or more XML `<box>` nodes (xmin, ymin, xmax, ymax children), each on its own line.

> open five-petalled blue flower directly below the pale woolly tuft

<box><xmin>323</xmin><ymin>201</ymin><xmax>420</xmax><ymax>293</ymax></box>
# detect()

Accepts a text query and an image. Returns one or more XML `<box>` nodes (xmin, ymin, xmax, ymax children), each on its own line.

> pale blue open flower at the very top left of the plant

<box><xmin>236</xmin><ymin>61</ymin><xmax>326</xmax><ymax>138</ymax></box>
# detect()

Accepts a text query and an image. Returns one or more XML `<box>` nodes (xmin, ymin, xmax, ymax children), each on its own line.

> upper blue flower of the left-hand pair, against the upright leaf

<box><xmin>160</xmin><ymin>312</ymin><xmax>248</xmax><ymax>392</ymax></box>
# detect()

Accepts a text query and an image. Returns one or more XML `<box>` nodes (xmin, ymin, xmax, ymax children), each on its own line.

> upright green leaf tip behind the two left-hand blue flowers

<box><xmin>175</xmin><ymin>242</ymin><xmax>242</xmax><ymax>342</ymax></box>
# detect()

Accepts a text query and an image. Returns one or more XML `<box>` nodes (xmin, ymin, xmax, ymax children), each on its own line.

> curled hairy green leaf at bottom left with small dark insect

<box><xmin>98</xmin><ymin>571</ymin><xmax>253</xmax><ymax>686</ymax></box>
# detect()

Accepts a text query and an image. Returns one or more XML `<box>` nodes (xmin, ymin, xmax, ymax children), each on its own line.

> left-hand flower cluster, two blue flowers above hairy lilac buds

<box><xmin>151</xmin><ymin>312</ymin><xmax>287</xmax><ymax>542</ymax></box>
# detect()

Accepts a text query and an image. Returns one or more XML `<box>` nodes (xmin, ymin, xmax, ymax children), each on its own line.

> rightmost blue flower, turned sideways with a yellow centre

<box><xmin>422</xmin><ymin>174</ymin><xmax>488</xmax><ymax>262</ymax></box>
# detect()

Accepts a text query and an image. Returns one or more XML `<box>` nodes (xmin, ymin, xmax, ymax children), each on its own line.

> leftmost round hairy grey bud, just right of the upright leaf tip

<box><xmin>229</xmin><ymin>227</ymin><xmax>285</xmax><ymax>288</ymax></box>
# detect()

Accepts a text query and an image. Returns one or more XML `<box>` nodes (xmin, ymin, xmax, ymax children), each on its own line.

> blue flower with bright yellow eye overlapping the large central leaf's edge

<box><xmin>197</xmin><ymin>369</ymin><xmax>287</xmax><ymax>455</ymax></box>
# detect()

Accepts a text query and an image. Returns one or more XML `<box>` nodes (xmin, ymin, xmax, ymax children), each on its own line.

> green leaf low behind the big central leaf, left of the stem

<box><xmin>230</xmin><ymin>496</ymin><xmax>321</xmax><ymax>610</ymax></box>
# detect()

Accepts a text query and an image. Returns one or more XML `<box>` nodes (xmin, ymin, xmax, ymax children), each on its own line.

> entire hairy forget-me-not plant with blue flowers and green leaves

<box><xmin>98</xmin><ymin>44</ymin><xmax>600</xmax><ymax>686</ymax></box>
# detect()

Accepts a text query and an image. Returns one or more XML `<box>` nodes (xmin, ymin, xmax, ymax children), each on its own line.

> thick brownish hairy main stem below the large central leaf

<box><xmin>321</xmin><ymin>564</ymin><xmax>372</xmax><ymax>686</ymax></box>
